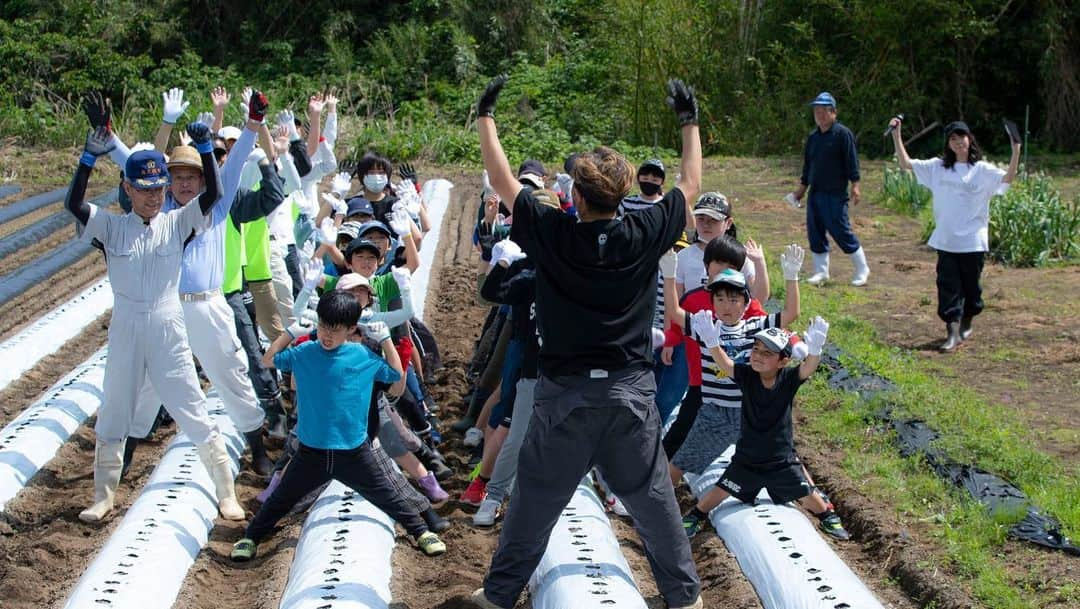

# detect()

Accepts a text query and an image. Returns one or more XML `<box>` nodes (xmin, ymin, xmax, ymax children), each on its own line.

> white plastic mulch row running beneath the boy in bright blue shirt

<box><xmin>281</xmin><ymin>179</ymin><xmax>454</xmax><ymax>609</ymax></box>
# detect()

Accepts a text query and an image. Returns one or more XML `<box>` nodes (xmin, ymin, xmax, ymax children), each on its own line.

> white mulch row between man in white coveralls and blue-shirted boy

<box><xmin>65</xmin><ymin>393</ymin><xmax>244</xmax><ymax>609</ymax></box>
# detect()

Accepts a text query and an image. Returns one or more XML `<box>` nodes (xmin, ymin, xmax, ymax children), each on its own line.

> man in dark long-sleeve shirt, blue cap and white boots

<box><xmin>795</xmin><ymin>92</ymin><xmax>870</xmax><ymax>286</ymax></box>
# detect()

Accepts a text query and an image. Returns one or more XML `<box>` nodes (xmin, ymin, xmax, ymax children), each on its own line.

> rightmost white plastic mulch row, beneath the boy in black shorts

<box><xmin>686</xmin><ymin>448</ymin><xmax>882</xmax><ymax>609</ymax></box>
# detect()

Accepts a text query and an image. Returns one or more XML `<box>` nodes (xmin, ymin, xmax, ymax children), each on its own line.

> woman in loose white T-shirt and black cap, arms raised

<box><xmin>889</xmin><ymin>119</ymin><xmax>1021</xmax><ymax>352</ymax></box>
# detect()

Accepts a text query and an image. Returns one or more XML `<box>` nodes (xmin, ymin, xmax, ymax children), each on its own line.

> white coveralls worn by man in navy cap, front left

<box><xmin>83</xmin><ymin>203</ymin><xmax>218</xmax><ymax>444</ymax></box>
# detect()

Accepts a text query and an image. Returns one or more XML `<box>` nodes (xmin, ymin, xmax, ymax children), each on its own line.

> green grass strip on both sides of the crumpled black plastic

<box><xmin>778</xmin><ymin>282</ymin><xmax>1080</xmax><ymax>609</ymax></box>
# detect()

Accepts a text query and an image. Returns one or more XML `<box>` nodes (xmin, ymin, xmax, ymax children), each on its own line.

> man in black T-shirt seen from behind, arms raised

<box><xmin>473</xmin><ymin>77</ymin><xmax>702</xmax><ymax>609</ymax></box>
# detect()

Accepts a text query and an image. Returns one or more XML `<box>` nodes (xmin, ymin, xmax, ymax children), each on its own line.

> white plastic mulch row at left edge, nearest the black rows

<box><xmin>0</xmin><ymin>280</ymin><xmax>112</xmax><ymax>390</ymax></box>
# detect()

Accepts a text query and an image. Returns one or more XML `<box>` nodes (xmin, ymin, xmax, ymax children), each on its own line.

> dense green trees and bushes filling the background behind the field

<box><xmin>0</xmin><ymin>0</ymin><xmax>1080</xmax><ymax>156</ymax></box>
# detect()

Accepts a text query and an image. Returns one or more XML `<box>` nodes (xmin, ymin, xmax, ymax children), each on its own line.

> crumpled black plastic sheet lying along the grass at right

<box><xmin>876</xmin><ymin>408</ymin><xmax>1080</xmax><ymax>556</ymax></box>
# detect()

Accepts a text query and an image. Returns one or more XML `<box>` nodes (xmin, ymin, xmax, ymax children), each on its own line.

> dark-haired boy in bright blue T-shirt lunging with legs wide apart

<box><xmin>231</xmin><ymin>290</ymin><xmax>446</xmax><ymax>561</ymax></box>
